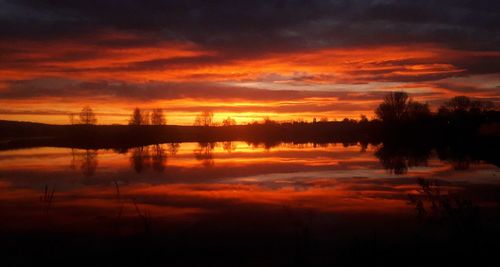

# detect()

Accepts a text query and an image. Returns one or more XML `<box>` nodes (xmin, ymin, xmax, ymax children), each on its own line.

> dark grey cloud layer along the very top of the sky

<box><xmin>0</xmin><ymin>0</ymin><xmax>500</xmax><ymax>53</ymax></box>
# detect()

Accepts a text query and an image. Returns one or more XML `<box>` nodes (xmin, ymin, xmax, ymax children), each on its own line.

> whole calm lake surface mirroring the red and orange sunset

<box><xmin>0</xmin><ymin>142</ymin><xmax>500</xmax><ymax>266</ymax></box>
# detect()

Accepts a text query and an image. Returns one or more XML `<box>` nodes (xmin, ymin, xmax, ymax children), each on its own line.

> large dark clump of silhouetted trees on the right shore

<box><xmin>375</xmin><ymin>92</ymin><xmax>500</xmax><ymax>139</ymax></box>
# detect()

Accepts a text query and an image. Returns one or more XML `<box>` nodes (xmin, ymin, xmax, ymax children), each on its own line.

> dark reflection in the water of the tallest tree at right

<box><xmin>375</xmin><ymin>144</ymin><xmax>431</xmax><ymax>175</ymax></box>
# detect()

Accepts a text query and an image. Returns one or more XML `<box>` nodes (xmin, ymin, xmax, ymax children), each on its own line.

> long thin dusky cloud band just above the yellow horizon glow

<box><xmin>0</xmin><ymin>78</ymin><xmax>398</xmax><ymax>101</ymax></box>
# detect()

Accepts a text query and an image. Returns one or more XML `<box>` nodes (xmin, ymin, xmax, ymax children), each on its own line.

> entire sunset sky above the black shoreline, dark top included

<box><xmin>0</xmin><ymin>0</ymin><xmax>500</xmax><ymax>125</ymax></box>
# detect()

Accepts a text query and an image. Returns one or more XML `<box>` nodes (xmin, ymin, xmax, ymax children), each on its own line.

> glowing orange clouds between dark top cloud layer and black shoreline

<box><xmin>0</xmin><ymin>35</ymin><xmax>500</xmax><ymax>124</ymax></box>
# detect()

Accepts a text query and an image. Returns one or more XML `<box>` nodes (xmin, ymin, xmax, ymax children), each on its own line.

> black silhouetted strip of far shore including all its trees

<box><xmin>0</xmin><ymin>92</ymin><xmax>500</xmax><ymax>151</ymax></box>
